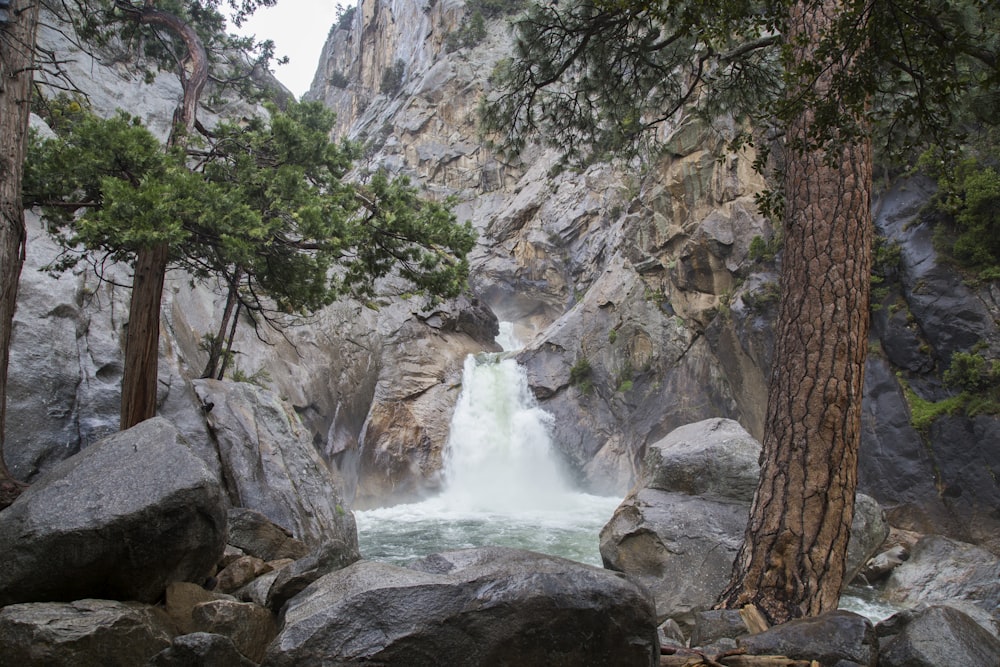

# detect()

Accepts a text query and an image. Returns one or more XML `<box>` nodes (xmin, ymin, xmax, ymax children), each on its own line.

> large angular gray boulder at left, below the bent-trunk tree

<box><xmin>0</xmin><ymin>418</ymin><xmax>226</xmax><ymax>605</ymax></box>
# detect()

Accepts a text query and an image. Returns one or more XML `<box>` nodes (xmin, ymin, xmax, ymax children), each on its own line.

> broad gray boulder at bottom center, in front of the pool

<box><xmin>262</xmin><ymin>548</ymin><xmax>659</xmax><ymax>667</ymax></box>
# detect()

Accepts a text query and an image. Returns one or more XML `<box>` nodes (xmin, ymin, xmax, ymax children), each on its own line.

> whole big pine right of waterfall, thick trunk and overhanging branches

<box><xmin>484</xmin><ymin>0</ymin><xmax>1000</xmax><ymax>622</ymax></box>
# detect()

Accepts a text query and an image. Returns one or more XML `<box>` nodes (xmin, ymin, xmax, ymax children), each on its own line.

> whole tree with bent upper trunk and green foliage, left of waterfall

<box><xmin>23</xmin><ymin>0</ymin><xmax>472</xmax><ymax>428</ymax></box>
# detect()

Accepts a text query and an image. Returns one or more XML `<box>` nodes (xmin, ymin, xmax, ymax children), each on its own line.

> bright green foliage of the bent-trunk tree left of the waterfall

<box><xmin>24</xmin><ymin>103</ymin><xmax>475</xmax><ymax>324</ymax></box>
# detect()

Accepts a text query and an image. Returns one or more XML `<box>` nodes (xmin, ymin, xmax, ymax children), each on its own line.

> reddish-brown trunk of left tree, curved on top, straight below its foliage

<box><xmin>121</xmin><ymin>3</ymin><xmax>208</xmax><ymax>430</ymax></box>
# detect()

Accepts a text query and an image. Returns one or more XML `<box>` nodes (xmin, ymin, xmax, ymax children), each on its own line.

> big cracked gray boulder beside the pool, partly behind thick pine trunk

<box><xmin>601</xmin><ymin>419</ymin><xmax>889</xmax><ymax>624</ymax></box>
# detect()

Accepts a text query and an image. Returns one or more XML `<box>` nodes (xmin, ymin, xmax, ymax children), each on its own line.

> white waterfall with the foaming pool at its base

<box><xmin>355</xmin><ymin>323</ymin><xmax>621</xmax><ymax>565</ymax></box>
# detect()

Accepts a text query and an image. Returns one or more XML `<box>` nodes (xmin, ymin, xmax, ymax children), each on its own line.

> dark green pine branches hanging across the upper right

<box><xmin>482</xmin><ymin>0</ymin><xmax>1000</xmax><ymax>170</ymax></box>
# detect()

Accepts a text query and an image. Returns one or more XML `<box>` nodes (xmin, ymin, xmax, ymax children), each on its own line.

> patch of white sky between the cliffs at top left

<box><xmin>230</xmin><ymin>0</ymin><xmax>342</xmax><ymax>98</ymax></box>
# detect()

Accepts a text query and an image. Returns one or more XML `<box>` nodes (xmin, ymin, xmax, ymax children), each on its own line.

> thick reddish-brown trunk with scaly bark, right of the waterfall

<box><xmin>720</xmin><ymin>0</ymin><xmax>872</xmax><ymax>623</ymax></box>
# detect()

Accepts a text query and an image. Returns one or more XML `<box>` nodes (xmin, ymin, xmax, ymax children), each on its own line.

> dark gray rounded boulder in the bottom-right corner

<box><xmin>876</xmin><ymin>606</ymin><xmax>1000</xmax><ymax>667</ymax></box>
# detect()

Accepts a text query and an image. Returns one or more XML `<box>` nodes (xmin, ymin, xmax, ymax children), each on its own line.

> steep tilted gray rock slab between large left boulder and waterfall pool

<box><xmin>194</xmin><ymin>380</ymin><xmax>357</xmax><ymax>545</ymax></box>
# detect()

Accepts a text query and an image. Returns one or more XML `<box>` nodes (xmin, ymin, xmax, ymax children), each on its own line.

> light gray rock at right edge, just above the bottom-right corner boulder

<box><xmin>884</xmin><ymin>535</ymin><xmax>1000</xmax><ymax>636</ymax></box>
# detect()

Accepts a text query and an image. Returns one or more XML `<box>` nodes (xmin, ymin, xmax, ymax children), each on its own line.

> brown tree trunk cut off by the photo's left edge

<box><xmin>0</xmin><ymin>0</ymin><xmax>38</xmax><ymax>509</ymax></box>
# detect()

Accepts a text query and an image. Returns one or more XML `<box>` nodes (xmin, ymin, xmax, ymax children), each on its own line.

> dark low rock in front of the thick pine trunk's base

<box><xmin>737</xmin><ymin>611</ymin><xmax>878</xmax><ymax>667</ymax></box>
